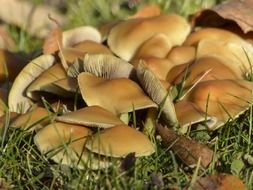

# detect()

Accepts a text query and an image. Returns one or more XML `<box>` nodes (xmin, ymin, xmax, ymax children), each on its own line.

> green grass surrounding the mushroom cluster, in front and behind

<box><xmin>0</xmin><ymin>0</ymin><xmax>253</xmax><ymax>190</ymax></box>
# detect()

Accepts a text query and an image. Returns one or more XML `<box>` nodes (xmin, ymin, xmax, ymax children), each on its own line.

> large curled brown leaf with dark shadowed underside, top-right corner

<box><xmin>193</xmin><ymin>0</ymin><xmax>253</xmax><ymax>33</ymax></box>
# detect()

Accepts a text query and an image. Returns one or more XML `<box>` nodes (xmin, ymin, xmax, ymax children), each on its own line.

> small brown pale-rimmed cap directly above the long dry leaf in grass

<box><xmin>175</xmin><ymin>101</ymin><xmax>216</xmax><ymax>128</ymax></box>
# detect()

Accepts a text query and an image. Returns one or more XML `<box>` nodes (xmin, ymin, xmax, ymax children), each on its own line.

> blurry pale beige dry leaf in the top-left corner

<box><xmin>0</xmin><ymin>0</ymin><xmax>66</xmax><ymax>38</ymax></box>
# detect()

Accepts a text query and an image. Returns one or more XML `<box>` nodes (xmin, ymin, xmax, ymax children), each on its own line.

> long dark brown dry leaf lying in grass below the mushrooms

<box><xmin>156</xmin><ymin>124</ymin><xmax>213</xmax><ymax>167</ymax></box>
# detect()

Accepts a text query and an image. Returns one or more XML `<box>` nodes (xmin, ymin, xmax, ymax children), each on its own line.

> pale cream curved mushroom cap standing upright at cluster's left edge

<box><xmin>8</xmin><ymin>55</ymin><xmax>55</xmax><ymax>112</ymax></box>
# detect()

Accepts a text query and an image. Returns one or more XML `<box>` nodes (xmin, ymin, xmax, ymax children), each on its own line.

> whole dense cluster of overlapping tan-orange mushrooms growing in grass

<box><xmin>0</xmin><ymin>14</ymin><xmax>253</xmax><ymax>169</ymax></box>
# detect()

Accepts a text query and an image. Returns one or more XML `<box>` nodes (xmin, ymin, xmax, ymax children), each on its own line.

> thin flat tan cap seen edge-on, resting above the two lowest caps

<box><xmin>56</xmin><ymin>106</ymin><xmax>124</xmax><ymax>128</ymax></box>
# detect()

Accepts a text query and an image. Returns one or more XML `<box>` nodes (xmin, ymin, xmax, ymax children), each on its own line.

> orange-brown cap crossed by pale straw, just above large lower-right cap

<box><xmin>171</xmin><ymin>57</ymin><xmax>242</xmax><ymax>87</ymax></box>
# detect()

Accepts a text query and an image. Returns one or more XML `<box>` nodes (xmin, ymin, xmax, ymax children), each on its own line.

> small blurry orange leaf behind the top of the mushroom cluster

<box><xmin>128</xmin><ymin>5</ymin><xmax>161</xmax><ymax>18</ymax></box>
